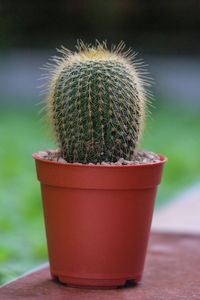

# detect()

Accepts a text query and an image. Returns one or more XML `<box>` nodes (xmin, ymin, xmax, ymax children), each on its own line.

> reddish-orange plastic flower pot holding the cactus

<box><xmin>33</xmin><ymin>153</ymin><xmax>167</xmax><ymax>288</ymax></box>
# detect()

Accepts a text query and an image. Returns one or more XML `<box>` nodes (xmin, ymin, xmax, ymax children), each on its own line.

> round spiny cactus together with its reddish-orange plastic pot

<box><xmin>33</xmin><ymin>42</ymin><xmax>167</xmax><ymax>288</ymax></box>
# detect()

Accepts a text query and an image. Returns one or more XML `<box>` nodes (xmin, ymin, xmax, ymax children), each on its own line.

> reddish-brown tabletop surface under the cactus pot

<box><xmin>0</xmin><ymin>233</ymin><xmax>200</xmax><ymax>300</ymax></box>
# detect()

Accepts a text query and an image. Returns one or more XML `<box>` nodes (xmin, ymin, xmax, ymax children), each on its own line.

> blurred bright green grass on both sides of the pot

<box><xmin>0</xmin><ymin>101</ymin><xmax>200</xmax><ymax>284</ymax></box>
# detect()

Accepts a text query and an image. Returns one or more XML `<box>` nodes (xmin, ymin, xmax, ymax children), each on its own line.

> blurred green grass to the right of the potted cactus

<box><xmin>142</xmin><ymin>100</ymin><xmax>200</xmax><ymax>206</ymax></box>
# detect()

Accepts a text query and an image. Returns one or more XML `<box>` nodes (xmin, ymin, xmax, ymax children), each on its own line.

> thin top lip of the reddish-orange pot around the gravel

<box><xmin>32</xmin><ymin>150</ymin><xmax>168</xmax><ymax>169</ymax></box>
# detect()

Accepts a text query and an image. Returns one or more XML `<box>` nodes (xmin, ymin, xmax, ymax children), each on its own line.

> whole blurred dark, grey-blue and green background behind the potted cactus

<box><xmin>0</xmin><ymin>0</ymin><xmax>200</xmax><ymax>284</ymax></box>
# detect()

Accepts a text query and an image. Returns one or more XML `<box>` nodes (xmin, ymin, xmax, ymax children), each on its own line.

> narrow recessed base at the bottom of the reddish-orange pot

<box><xmin>51</xmin><ymin>273</ymin><xmax>142</xmax><ymax>289</ymax></box>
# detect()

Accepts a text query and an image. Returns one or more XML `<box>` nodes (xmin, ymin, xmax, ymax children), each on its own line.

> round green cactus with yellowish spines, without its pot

<box><xmin>43</xmin><ymin>42</ymin><xmax>148</xmax><ymax>164</ymax></box>
